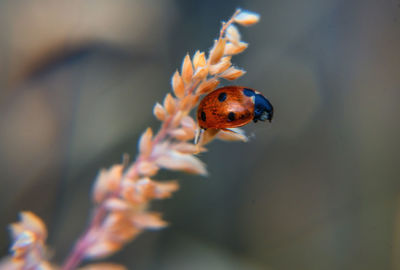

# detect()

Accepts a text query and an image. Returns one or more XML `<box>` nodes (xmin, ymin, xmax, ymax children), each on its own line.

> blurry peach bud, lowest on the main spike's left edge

<box><xmin>93</xmin><ymin>164</ymin><xmax>124</xmax><ymax>203</ymax></box>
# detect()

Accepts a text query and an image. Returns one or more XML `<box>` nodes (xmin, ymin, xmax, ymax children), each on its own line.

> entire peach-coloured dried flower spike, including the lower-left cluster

<box><xmin>0</xmin><ymin>10</ymin><xmax>259</xmax><ymax>270</ymax></box>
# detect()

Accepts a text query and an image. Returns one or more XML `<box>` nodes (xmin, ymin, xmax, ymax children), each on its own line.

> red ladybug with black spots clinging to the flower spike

<box><xmin>197</xmin><ymin>86</ymin><xmax>274</xmax><ymax>129</ymax></box>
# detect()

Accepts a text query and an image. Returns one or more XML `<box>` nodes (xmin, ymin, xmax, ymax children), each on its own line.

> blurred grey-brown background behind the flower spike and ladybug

<box><xmin>0</xmin><ymin>0</ymin><xmax>400</xmax><ymax>270</ymax></box>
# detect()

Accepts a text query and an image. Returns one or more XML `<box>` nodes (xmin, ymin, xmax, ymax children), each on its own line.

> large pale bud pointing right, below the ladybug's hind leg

<box><xmin>156</xmin><ymin>150</ymin><xmax>207</xmax><ymax>175</ymax></box>
